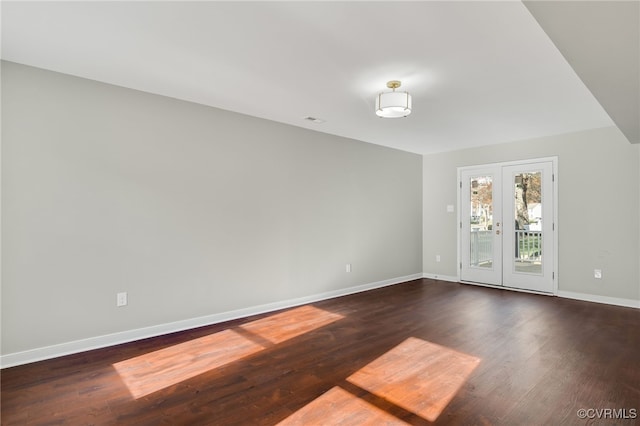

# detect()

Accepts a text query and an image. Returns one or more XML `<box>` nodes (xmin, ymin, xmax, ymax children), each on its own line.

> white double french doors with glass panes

<box><xmin>458</xmin><ymin>158</ymin><xmax>556</xmax><ymax>293</ymax></box>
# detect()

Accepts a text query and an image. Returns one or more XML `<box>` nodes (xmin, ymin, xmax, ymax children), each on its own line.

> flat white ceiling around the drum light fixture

<box><xmin>2</xmin><ymin>1</ymin><xmax>613</xmax><ymax>154</ymax></box>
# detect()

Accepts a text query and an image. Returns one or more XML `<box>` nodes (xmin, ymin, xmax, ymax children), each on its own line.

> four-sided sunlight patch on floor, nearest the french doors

<box><xmin>347</xmin><ymin>337</ymin><xmax>480</xmax><ymax>421</ymax></box>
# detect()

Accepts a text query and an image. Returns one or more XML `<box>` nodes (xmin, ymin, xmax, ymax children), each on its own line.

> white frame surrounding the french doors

<box><xmin>456</xmin><ymin>156</ymin><xmax>560</xmax><ymax>295</ymax></box>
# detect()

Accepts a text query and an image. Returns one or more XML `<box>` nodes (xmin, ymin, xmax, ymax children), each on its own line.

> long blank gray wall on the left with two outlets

<box><xmin>2</xmin><ymin>62</ymin><xmax>422</xmax><ymax>354</ymax></box>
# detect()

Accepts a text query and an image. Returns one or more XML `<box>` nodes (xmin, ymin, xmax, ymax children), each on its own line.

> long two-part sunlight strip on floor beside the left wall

<box><xmin>113</xmin><ymin>306</ymin><xmax>343</xmax><ymax>399</ymax></box>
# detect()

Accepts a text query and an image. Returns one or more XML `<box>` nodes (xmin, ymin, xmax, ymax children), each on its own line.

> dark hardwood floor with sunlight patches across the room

<box><xmin>1</xmin><ymin>279</ymin><xmax>640</xmax><ymax>425</ymax></box>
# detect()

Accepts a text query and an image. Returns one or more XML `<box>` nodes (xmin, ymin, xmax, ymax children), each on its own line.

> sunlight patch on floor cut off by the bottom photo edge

<box><xmin>278</xmin><ymin>386</ymin><xmax>408</xmax><ymax>426</ymax></box>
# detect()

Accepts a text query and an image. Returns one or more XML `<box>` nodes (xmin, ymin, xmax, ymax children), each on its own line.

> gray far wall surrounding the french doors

<box><xmin>423</xmin><ymin>127</ymin><xmax>640</xmax><ymax>301</ymax></box>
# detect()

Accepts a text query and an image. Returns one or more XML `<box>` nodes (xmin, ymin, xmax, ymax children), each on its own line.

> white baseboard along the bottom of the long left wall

<box><xmin>0</xmin><ymin>273</ymin><xmax>422</xmax><ymax>368</ymax></box>
